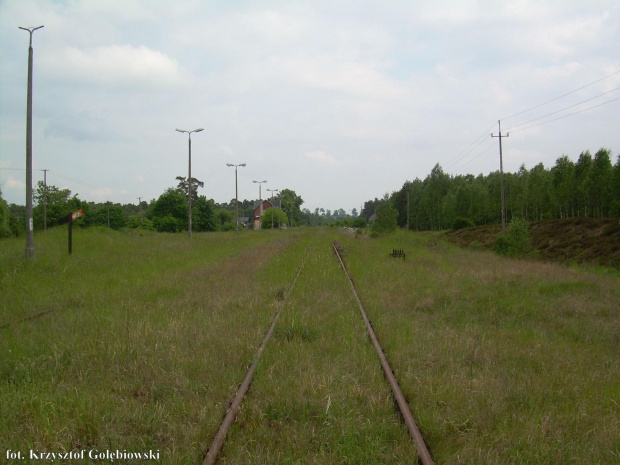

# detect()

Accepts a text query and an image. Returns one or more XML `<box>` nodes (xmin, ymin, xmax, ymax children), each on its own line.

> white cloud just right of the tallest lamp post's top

<box><xmin>41</xmin><ymin>45</ymin><xmax>184</xmax><ymax>87</ymax></box>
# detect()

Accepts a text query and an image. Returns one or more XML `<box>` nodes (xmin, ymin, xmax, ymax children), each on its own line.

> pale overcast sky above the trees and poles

<box><xmin>0</xmin><ymin>0</ymin><xmax>620</xmax><ymax>212</ymax></box>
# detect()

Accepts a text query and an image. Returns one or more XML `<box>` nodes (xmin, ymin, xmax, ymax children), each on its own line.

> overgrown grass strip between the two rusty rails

<box><xmin>211</xmin><ymin>241</ymin><xmax>418</xmax><ymax>464</ymax></box>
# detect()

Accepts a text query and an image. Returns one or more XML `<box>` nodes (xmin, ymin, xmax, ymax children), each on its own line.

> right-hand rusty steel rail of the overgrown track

<box><xmin>332</xmin><ymin>243</ymin><xmax>434</xmax><ymax>465</ymax></box>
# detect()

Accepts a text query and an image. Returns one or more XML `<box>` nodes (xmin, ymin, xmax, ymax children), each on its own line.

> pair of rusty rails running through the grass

<box><xmin>202</xmin><ymin>243</ymin><xmax>434</xmax><ymax>465</ymax></box>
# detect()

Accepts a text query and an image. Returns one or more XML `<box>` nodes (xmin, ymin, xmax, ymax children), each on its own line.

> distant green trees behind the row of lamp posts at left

<box><xmin>0</xmin><ymin>176</ymin><xmax>358</xmax><ymax>237</ymax></box>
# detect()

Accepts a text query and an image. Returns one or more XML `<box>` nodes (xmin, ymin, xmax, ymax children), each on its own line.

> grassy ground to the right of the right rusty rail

<box><xmin>341</xmin><ymin>229</ymin><xmax>620</xmax><ymax>465</ymax></box>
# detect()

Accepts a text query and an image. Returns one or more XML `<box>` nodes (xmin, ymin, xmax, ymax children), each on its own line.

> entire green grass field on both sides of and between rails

<box><xmin>0</xmin><ymin>228</ymin><xmax>620</xmax><ymax>464</ymax></box>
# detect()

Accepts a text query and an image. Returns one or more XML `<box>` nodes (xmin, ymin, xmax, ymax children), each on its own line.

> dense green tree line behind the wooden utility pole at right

<box><xmin>361</xmin><ymin>148</ymin><xmax>620</xmax><ymax>231</ymax></box>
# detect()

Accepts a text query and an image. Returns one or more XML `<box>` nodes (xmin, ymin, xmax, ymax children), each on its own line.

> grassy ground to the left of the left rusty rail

<box><xmin>0</xmin><ymin>226</ymin><xmax>308</xmax><ymax>463</ymax></box>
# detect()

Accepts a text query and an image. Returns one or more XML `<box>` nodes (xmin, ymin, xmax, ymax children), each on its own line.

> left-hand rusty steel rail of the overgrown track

<box><xmin>202</xmin><ymin>247</ymin><xmax>312</xmax><ymax>465</ymax></box>
